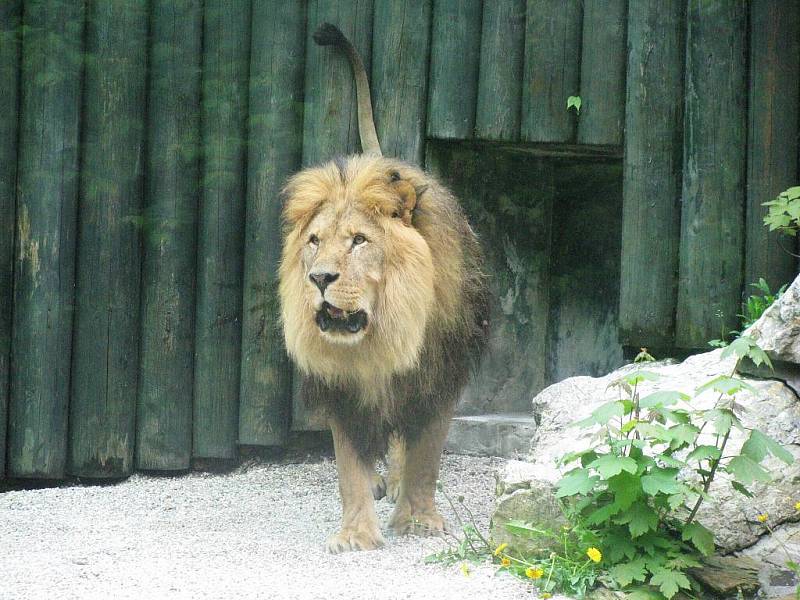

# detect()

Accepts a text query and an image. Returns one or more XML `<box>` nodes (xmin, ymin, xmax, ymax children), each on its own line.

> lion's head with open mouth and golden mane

<box><xmin>280</xmin><ymin>156</ymin><xmax>434</xmax><ymax>380</ymax></box>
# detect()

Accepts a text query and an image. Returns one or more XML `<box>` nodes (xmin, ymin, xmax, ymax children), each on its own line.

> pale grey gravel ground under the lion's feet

<box><xmin>0</xmin><ymin>456</ymin><xmax>535</xmax><ymax>600</ymax></box>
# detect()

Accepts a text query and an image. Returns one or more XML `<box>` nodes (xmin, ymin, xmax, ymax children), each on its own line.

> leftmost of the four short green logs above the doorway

<box><xmin>428</xmin><ymin>0</ymin><xmax>483</xmax><ymax>139</ymax></box>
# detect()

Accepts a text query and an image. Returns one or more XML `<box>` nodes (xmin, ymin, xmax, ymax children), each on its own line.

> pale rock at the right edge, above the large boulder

<box><xmin>745</xmin><ymin>275</ymin><xmax>800</xmax><ymax>364</ymax></box>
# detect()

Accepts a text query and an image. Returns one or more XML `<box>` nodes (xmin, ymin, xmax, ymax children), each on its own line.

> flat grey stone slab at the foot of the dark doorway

<box><xmin>445</xmin><ymin>414</ymin><xmax>536</xmax><ymax>458</ymax></box>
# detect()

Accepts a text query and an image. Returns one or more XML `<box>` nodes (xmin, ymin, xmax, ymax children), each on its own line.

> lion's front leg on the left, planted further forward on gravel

<box><xmin>327</xmin><ymin>420</ymin><xmax>383</xmax><ymax>554</ymax></box>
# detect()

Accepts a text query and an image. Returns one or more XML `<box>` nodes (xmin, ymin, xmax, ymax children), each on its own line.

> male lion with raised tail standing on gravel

<box><xmin>279</xmin><ymin>24</ymin><xmax>488</xmax><ymax>553</ymax></box>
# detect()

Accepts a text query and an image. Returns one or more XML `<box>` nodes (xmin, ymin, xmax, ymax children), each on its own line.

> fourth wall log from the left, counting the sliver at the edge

<box><xmin>136</xmin><ymin>0</ymin><xmax>203</xmax><ymax>470</ymax></box>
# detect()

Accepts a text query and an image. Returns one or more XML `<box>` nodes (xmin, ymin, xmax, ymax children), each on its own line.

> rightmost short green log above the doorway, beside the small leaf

<box><xmin>578</xmin><ymin>0</ymin><xmax>636</xmax><ymax>146</ymax></box>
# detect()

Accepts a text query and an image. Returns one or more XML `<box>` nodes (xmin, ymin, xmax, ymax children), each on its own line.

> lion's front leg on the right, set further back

<box><xmin>389</xmin><ymin>410</ymin><xmax>452</xmax><ymax>535</ymax></box>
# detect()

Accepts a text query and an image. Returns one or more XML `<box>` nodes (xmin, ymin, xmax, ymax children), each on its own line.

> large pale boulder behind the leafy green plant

<box><xmin>500</xmin><ymin>350</ymin><xmax>800</xmax><ymax>553</ymax></box>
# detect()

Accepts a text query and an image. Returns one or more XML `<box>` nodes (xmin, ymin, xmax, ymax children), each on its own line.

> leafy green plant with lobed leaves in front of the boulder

<box><xmin>557</xmin><ymin>337</ymin><xmax>793</xmax><ymax>598</ymax></box>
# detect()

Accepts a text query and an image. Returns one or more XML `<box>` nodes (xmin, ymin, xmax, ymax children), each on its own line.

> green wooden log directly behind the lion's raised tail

<box><xmin>303</xmin><ymin>0</ymin><xmax>372</xmax><ymax>165</ymax></box>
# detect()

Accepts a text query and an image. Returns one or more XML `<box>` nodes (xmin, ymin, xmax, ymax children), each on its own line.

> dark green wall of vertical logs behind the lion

<box><xmin>0</xmin><ymin>0</ymin><xmax>800</xmax><ymax>479</ymax></box>
